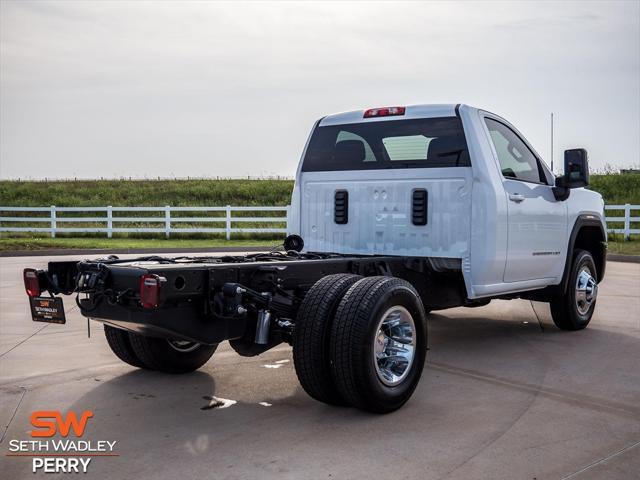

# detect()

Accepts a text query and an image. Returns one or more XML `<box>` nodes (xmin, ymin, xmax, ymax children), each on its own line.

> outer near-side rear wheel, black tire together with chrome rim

<box><xmin>330</xmin><ymin>277</ymin><xmax>427</xmax><ymax>413</ymax></box>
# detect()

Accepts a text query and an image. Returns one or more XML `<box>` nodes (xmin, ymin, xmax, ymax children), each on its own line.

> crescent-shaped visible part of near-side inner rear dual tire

<box><xmin>293</xmin><ymin>273</ymin><xmax>362</xmax><ymax>405</ymax></box>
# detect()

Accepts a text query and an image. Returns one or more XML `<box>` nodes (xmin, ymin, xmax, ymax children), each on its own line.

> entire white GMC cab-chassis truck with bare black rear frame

<box><xmin>24</xmin><ymin>105</ymin><xmax>606</xmax><ymax>413</ymax></box>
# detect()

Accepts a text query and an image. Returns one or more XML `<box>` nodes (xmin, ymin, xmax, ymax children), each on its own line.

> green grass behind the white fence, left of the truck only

<box><xmin>0</xmin><ymin>180</ymin><xmax>293</xmax><ymax>244</ymax></box>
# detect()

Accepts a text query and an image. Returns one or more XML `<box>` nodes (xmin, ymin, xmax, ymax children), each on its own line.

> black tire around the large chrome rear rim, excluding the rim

<box><xmin>330</xmin><ymin>277</ymin><xmax>427</xmax><ymax>413</ymax></box>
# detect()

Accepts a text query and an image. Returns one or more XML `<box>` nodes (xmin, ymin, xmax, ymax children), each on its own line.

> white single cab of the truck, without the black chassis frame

<box><xmin>289</xmin><ymin>104</ymin><xmax>606</xmax><ymax>299</ymax></box>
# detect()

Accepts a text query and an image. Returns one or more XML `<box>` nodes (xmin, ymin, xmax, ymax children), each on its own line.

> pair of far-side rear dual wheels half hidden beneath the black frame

<box><xmin>104</xmin><ymin>324</ymin><xmax>218</xmax><ymax>373</ymax></box>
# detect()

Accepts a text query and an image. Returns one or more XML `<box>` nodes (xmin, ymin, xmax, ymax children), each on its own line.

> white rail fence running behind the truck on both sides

<box><xmin>0</xmin><ymin>203</ymin><xmax>640</xmax><ymax>240</ymax></box>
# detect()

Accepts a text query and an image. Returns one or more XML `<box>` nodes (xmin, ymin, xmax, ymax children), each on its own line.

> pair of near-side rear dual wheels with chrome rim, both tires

<box><xmin>293</xmin><ymin>274</ymin><xmax>427</xmax><ymax>413</ymax></box>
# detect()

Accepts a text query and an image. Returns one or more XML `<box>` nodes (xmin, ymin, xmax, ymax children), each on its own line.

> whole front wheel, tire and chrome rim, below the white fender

<box><xmin>550</xmin><ymin>250</ymin><xmax>598</xmax><ymax>330</ymax></box>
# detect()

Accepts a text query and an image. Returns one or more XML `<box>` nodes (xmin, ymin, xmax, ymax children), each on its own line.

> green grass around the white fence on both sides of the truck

<box><xmin>0</xmin><ymin>174</ymin><xmax>640</xmax><ymax>254</ymax></box>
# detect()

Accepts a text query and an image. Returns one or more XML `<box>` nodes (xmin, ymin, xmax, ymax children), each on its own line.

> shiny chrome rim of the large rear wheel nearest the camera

<box><xmin>373</xmin><ymin>305</ymin><xmax>416</xmax><ymax>387</ymax></box>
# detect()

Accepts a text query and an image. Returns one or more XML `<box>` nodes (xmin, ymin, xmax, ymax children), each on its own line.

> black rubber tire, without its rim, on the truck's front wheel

<box><xmin>550</xmin><ymin>250</ymin><xmax>598</xmax><ymax>330</ymax></box>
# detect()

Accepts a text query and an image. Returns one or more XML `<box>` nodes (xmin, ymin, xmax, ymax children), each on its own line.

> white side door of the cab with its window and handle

<box><xmin>485</xmin><ymin>118</ymin><xmax>567</xmax><ymax>282</ymax></box>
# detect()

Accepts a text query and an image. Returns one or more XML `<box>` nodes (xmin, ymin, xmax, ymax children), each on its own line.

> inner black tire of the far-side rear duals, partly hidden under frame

<box><xmin>129</xmin><ymin>333</ymin><xmax>218</xmax><ymax>373</ymax></box>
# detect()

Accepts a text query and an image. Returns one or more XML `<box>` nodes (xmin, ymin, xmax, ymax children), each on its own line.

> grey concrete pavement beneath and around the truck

<box><xmin>0</xmin><ymin>253</ymin><xmax>640</xmax><ymax>480</ymax></box>
